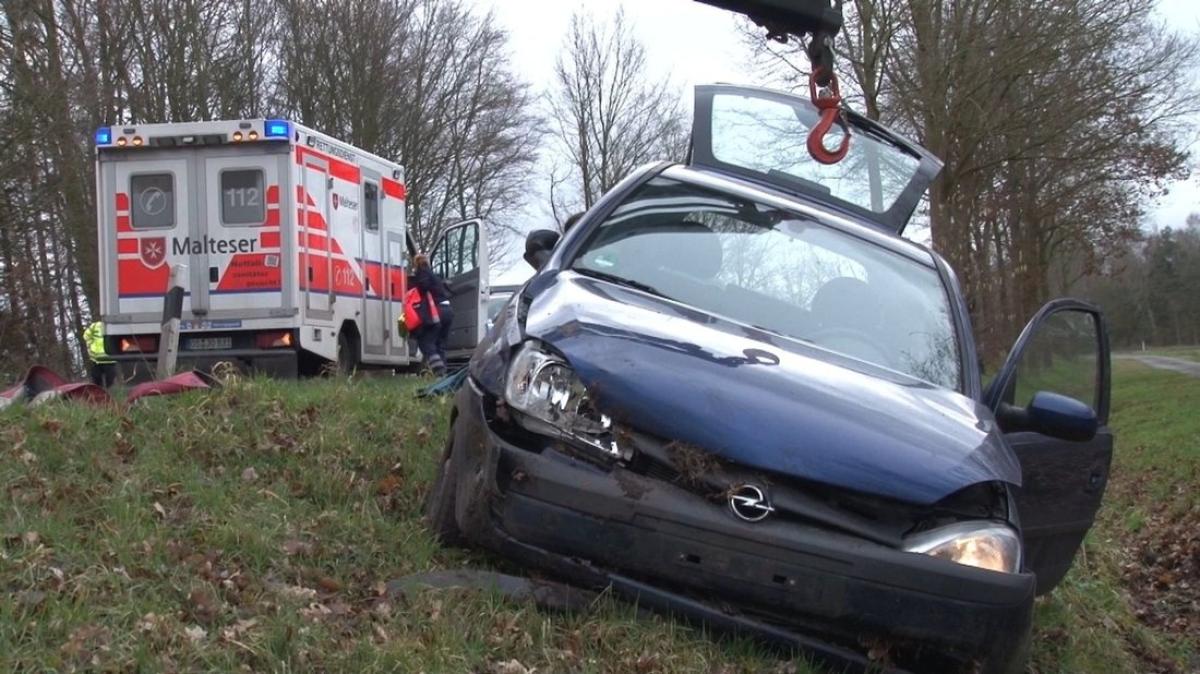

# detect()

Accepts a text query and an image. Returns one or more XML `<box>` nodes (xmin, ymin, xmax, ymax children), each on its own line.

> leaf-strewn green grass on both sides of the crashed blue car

<box><xmin>0</xmin><ymin>361</ymin><xmax>1200</xmax><ymax>673</ymax></box>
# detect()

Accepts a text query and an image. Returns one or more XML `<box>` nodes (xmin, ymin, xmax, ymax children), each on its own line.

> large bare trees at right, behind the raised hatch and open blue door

<box><xmin>739</xmin><ymin>0</ymin><xmax>1200</xmax><ymax>355</ymax></box>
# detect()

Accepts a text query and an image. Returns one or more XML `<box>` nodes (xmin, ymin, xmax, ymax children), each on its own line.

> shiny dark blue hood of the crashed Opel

<box><xmin>526</xmin><ymin>272</ymin><xmax>1020</xmax><ymax>504</ymax></box>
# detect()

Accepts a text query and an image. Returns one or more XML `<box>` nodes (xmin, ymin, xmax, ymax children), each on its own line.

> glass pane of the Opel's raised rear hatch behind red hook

<box><xmin>712</xmin><ymin>94</ymin><xmax>924</xmax><ymax>215</ymax></box>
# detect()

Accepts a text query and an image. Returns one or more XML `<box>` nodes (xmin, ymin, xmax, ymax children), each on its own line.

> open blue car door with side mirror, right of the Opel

<box><xmin>985</xmin><ymin>300</ymin><xmax>1112</xmax><ymax>595</ymax></box>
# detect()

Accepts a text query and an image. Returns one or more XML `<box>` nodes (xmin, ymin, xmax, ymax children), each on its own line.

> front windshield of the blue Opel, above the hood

<box><xmin>571</xmin><ymin>176</ymin><xmax>960</xmax><ymax>389</ymax></box>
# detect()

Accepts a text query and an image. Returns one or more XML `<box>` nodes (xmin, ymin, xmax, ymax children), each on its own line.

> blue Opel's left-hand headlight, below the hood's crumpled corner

<box><xmin>504</xmin><ymin>341</ymin><xmax>630</xmax><ymax>459</ymax></box>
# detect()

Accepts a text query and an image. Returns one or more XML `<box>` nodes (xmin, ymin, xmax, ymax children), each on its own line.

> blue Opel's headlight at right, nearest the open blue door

<box><xmin>904</xmin><ymin>522</ymin><xmax>1021</xmax><ymax>573</ymax></box>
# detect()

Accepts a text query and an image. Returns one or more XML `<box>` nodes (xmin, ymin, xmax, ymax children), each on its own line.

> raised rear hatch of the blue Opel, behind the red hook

<box><xmin>688</xmin><ymin>84</ymin><xmax>942</xmax><ymax>234</ymax></box>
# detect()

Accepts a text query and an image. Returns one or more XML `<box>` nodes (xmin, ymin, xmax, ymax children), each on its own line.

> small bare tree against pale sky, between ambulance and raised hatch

<box><xmin>546</xmin><ymin>11</ymin><xmax>688</xmax><ymax>223</ymax></box>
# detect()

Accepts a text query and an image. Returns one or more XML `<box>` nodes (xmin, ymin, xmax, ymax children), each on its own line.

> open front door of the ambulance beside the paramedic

<box><xmin>430</xmin><ymin>219</ymin><xmax>488</xmax><ymax>360</ymax></box>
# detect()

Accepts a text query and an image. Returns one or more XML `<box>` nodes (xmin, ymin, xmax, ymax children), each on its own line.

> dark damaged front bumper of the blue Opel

<box><xmin>455</xmin><ymin>386</ymin><xmax>1034</xmax><ymax>673</ymax></box>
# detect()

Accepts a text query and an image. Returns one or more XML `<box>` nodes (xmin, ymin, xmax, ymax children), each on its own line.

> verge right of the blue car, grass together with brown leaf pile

<box><xmin>1032</xmin><ymin>359</ymin><xmax>1200</xmax><ymax>674</ymax></box>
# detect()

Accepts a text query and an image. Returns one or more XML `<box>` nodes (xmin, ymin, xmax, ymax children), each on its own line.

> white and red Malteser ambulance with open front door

<box><xmin>96</xmin><ymin>120</ymin><xmax>488</xmax><ymax>375</ymax></box>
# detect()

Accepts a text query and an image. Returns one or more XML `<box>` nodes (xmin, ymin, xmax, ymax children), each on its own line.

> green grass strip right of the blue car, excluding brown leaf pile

<box><xmin>1033</xmin><ymin>360</ymin><xmax>1200</xmax><ymax>674</ymax></box>
